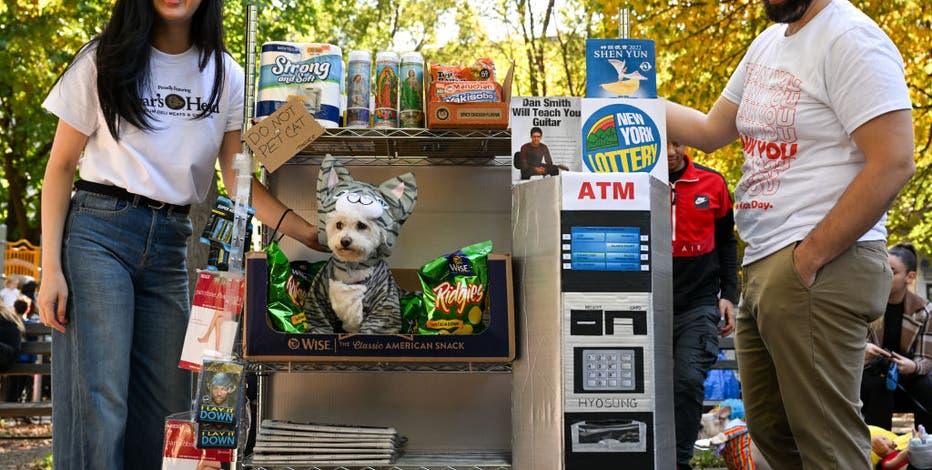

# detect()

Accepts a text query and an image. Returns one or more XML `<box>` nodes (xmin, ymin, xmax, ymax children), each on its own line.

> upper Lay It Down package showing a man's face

<box><xmin>195</xmin><ymin>360</ymin><xmax>243</xmax><ymax>427</ymax></box>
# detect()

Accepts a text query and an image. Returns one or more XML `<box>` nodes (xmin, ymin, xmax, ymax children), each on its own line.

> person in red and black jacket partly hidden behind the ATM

<box><xmin>667</xmin><ymin>142</ymin><xmax>738</xmax><ymax>469</ymax></box>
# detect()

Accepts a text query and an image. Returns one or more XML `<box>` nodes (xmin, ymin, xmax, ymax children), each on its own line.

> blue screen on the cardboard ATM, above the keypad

<box><xmin>570</xmin><ymin>227</ymin><xmax>641</xmax><ymax>271</ymax></box>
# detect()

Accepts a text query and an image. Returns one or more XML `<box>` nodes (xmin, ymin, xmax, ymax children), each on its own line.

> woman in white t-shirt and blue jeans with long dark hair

<box><xmin>39</xmin><ymin>0</ymin><xmax>320</xmax><ymax>469</ymax></box>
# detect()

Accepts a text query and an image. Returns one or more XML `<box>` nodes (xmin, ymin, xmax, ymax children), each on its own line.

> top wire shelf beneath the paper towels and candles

<box><xmin>287</xmin><ymin>128</ymin><xmax>511</xmax><ymax>166</ymax></box>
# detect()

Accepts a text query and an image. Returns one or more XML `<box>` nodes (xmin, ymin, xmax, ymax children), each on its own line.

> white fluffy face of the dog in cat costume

<box><xmin>327</xmin><ymin>211</ymin><xmax>385</xmax><ymax>263</ymax></box>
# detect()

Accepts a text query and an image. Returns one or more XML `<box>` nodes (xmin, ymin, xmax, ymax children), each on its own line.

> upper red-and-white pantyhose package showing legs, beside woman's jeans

<box><xmin>178</xmin><ymin>271</ymin><xmax>246</xmax><ymax>372</ymax></box>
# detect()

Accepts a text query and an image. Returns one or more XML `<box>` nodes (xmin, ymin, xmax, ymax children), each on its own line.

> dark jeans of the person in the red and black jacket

<box><xmin>673</xmin><ymin>305</ymin><xmax>722</xmax><ymax>467</ymax></box>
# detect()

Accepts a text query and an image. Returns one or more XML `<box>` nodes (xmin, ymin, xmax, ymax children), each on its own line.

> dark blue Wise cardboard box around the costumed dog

<box><xmin>243</xmin><ymin>252</ymin><xmax>515</xmax><ymax>363</ymax></box>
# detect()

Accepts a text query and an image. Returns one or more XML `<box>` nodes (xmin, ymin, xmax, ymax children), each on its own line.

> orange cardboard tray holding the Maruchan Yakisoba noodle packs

<box><xmin>427</xmin><ymin>64</ymin><xmax>515</xmax><ymax>129</ymax></box>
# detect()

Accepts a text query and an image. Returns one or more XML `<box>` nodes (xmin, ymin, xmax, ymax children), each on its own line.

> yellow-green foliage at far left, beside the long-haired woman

<box><xmin>0</xmin><ymin>0</ymin><xmax>102</xmax><ymax>242</ymax></box>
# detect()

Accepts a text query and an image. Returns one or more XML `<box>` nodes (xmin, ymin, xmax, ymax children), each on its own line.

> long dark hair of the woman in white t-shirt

<box><xmin>65</xmin><ymin>0</ymin><xmax>226</xmax><ymax>139</ymax></box>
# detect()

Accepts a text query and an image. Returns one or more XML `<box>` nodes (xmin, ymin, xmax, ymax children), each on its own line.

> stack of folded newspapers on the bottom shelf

<box><xmin>252</xmin><ymin>419</ymin><xmax>405</xmax><ymax>466</ymax></box>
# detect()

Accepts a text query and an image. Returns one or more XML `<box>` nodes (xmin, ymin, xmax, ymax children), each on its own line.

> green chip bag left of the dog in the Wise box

<box><xmin>265</xmin><ymin>242</ymin><xmax>327</xmax><ymax>333</ymax></box>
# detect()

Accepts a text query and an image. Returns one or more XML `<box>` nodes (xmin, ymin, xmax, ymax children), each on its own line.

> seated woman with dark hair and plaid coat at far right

<box><xmin>861</xmin><ymin>243</ymin><xmax>932</xmax><ymax>430</ymax></box>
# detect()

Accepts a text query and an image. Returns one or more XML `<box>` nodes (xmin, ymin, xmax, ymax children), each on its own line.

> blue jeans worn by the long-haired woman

<box><xmin>52</xmin><ymin>191</ymin><xmax>192</xmax><ymax>470</ymax></box>
